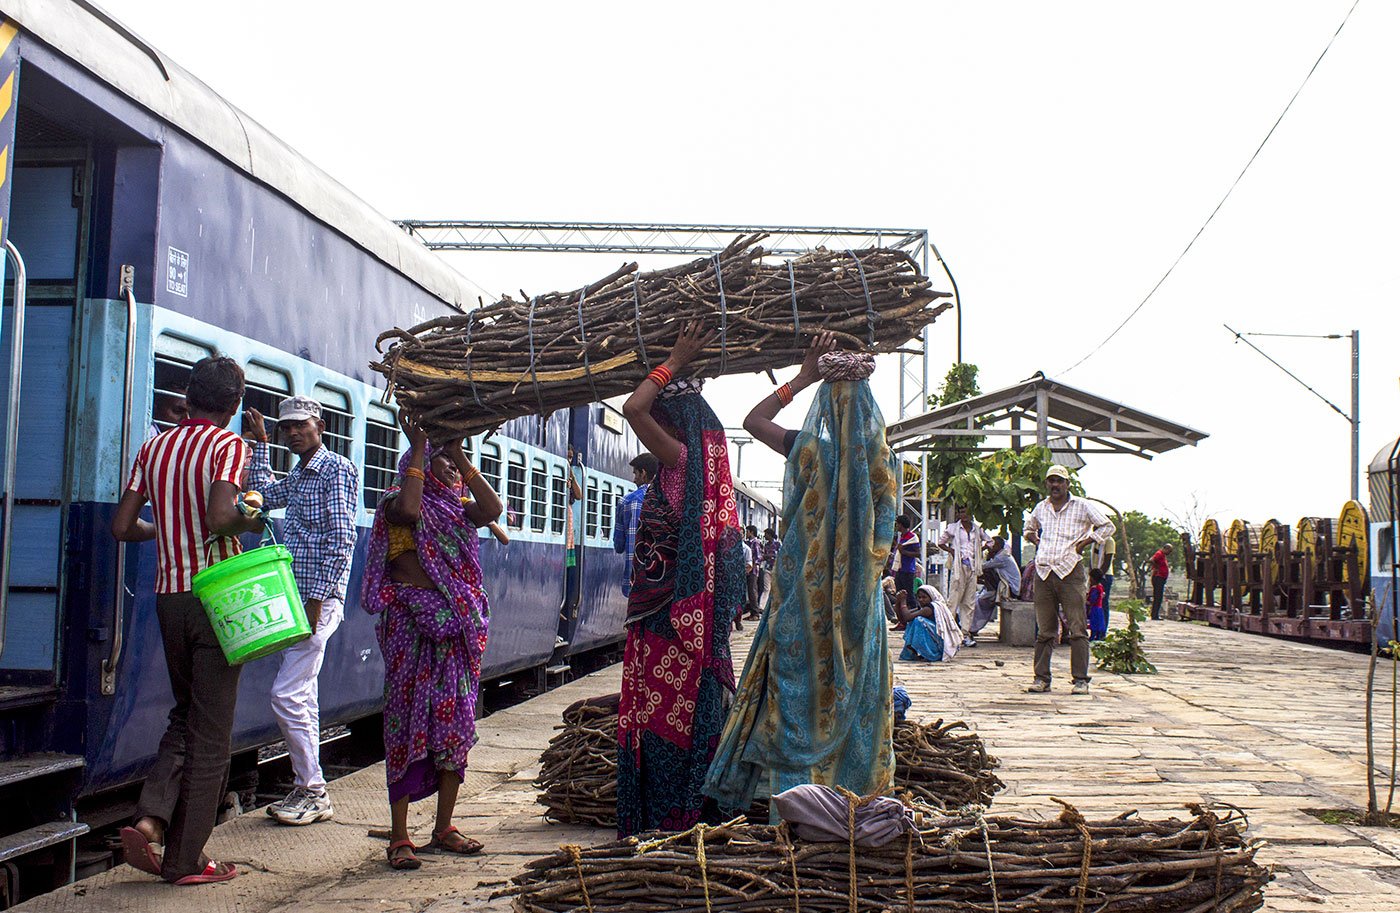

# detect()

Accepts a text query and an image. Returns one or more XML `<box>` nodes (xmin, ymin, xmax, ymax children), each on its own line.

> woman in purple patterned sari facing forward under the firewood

<box><xmin>363</xmin><ymin>421</ymin><xmax>501</xmax><ymax>868</ymax></box>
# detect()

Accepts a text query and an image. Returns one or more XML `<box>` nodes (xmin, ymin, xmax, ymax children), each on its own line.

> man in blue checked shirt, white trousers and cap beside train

<box><xmin>244</xmin><ymin>396</ymin><xmax>360</xmax><ymax>825</ymax></box>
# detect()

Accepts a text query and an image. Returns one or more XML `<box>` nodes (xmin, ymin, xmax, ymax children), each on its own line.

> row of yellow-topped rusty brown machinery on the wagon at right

<box><xmin>1177</xmin><ymin>501</ymin><xmax>1371</xmax><ymax>647</ymax></box>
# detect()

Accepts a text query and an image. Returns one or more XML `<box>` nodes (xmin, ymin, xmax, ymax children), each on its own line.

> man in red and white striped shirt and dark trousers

<box><xmin>112</xmin><ymin>357</ymin><xmax>262</xmax><ymax>885</ymax></box>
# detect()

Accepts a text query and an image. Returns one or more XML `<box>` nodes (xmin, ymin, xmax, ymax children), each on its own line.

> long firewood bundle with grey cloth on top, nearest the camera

<box><xmin>497</xmin><ymin>805</ymin><xmax>1271</xmax><ymax>913</ymax></box>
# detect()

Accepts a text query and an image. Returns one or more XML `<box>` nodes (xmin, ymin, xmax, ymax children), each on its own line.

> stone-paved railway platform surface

<box><xmin>17</xmin><ymin>618</ymin><xmax>1400</xmax><ymax>913</ymax></box>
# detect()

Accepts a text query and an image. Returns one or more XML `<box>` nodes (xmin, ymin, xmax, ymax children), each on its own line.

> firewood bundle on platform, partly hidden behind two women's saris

<box><xmin>535</xmin><ymin>695</ymin><xmax>1005</xmax><ymax>828</ymax></box>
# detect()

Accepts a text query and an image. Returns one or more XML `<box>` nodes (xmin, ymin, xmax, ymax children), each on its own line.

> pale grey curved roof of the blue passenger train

<box><xmin>0</xmin><ymin>0</ymin><xmax>477</xmax><ymax>309</ymax></box>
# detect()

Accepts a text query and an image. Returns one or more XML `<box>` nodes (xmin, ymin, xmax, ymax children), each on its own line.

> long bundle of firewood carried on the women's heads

<box><xmin>371</xmin><ymin>235</ymin><xmax>951</xmax><ymax>437</ymax></box>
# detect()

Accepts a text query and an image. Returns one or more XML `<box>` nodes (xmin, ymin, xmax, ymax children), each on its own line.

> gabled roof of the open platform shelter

<box><xmin>886</xmin><ymin>371</ymin><xmax>1208</xmax><ymax>459</ymax></box>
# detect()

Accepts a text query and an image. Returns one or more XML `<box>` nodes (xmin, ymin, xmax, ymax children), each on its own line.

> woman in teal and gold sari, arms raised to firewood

<box><xmin>704</xmin><ymin>333</ymin><xmax>896</xmax><ymax>812</ymax></box>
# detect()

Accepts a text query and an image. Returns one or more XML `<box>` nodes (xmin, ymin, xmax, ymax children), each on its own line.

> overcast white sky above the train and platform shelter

<box><xmin>104</xmin><ymin>0</ymin><xmax>1400</xmax><ymax>532</ymax></box>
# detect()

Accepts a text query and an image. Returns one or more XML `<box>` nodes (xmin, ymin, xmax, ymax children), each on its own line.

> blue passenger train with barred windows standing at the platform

<box><xmin>0</xmin><ymin>0</ymin><xmax>774</xmax><ymax>906</ymax></box>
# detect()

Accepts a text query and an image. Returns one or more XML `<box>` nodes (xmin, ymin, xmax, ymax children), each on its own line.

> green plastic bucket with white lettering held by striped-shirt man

<box><xmin>195</xmin><ymin>545</ymin><xmax>311</xmax><ymax>665</ymax></box>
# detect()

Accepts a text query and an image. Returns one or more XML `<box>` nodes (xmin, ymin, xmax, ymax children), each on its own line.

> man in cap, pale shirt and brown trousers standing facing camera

<box><xmin>1026</xmin><ymin>466</ymin><xmax>1113</xmax><ymax>695</ymax></box>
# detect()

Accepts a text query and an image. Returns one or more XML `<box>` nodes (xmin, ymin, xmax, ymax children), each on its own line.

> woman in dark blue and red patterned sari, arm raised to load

<box><xmin>617</xmin><ymin>321</ymin><xmax>746</xmax><ymax>837</ymax></box>
